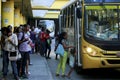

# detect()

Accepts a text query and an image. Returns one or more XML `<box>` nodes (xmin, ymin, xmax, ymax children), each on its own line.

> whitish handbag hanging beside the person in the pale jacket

<box><xmin>8</xmin><ymin>49</ymin><xmax>22</xmax><ymax>61</ymax></box>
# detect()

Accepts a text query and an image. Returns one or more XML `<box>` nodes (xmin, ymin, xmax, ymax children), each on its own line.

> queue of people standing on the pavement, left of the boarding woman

<box><xmin>0</xmin><ymin>24</ymin><xmax>51</xmax><ymax>80</ymax></box>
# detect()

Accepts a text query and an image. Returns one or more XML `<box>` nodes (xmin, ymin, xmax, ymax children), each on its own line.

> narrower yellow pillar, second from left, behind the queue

<box><xmin>14</xmin><ymin>8</ymin><xmax>20</xmax><ymax>27</ymax></box>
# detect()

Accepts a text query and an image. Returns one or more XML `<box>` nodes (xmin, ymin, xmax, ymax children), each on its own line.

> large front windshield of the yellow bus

<box><xmin>85</xmin><ymin>6</ymin><xmax>120</xmax><ymax>41</ymax></box>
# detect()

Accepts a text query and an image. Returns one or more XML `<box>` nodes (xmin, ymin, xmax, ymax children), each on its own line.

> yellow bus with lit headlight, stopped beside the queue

<box><xmin>59</xmin><ymin>0</ymin><xmax>120</xmax><ymax>70</ymax></box>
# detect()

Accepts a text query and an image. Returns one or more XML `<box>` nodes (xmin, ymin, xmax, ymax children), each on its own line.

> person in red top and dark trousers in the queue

<box><xmin>39</xmin><ymin>27</ymin><xmax>46</xmax><ymax>56</ymax></box>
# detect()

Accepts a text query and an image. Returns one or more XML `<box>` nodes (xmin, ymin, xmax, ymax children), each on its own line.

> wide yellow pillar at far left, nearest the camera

<box><xmin>2</xmin><ymin>0</ymin><xmax>14</xmax><ymax>27</ymax></box>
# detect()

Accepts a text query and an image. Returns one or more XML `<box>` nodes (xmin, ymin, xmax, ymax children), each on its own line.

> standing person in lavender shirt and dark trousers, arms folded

<box><xmin>18</xmin><ymin>24</ymin><xmax>31</xmax><ymax>78</ymax></box>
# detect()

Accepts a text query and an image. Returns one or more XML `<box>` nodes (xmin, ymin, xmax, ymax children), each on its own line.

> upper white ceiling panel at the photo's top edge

<box><xmin>31</xmin><ymin>0</ymin><xmax>55</xmax><ymax>7</ymax></box>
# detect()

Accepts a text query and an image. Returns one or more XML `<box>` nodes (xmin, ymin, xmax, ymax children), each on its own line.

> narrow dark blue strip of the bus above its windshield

<box><xmin>84</xmin><ymin>0</ymin><xmax>120</xmax><ymax>3</ymax></box>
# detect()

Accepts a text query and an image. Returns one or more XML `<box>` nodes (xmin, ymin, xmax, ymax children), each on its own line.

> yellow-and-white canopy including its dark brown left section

<box><xmin>2</xmin><ymin>0</ymin><xmax>71</xmax><ymax>18</ymax></box>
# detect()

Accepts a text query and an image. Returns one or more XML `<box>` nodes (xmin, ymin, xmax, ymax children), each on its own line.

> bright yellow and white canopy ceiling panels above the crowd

<box><xmin>30</xmin><ymin>0</ymin><xmax>71</xmax><ymax>18</ymax></box>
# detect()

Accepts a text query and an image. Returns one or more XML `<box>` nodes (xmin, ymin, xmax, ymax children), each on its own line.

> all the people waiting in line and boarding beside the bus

<box><xmin>1</xmin><ymin>24</ymin><xmax>76</xmax><ymax>80</ymax></box>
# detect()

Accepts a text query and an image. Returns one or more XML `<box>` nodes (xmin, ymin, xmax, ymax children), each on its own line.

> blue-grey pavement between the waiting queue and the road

<box><xmin>0</xmin><ymin>54</ymin><xmax>53</xmax><ymax>80</ymax></box>
